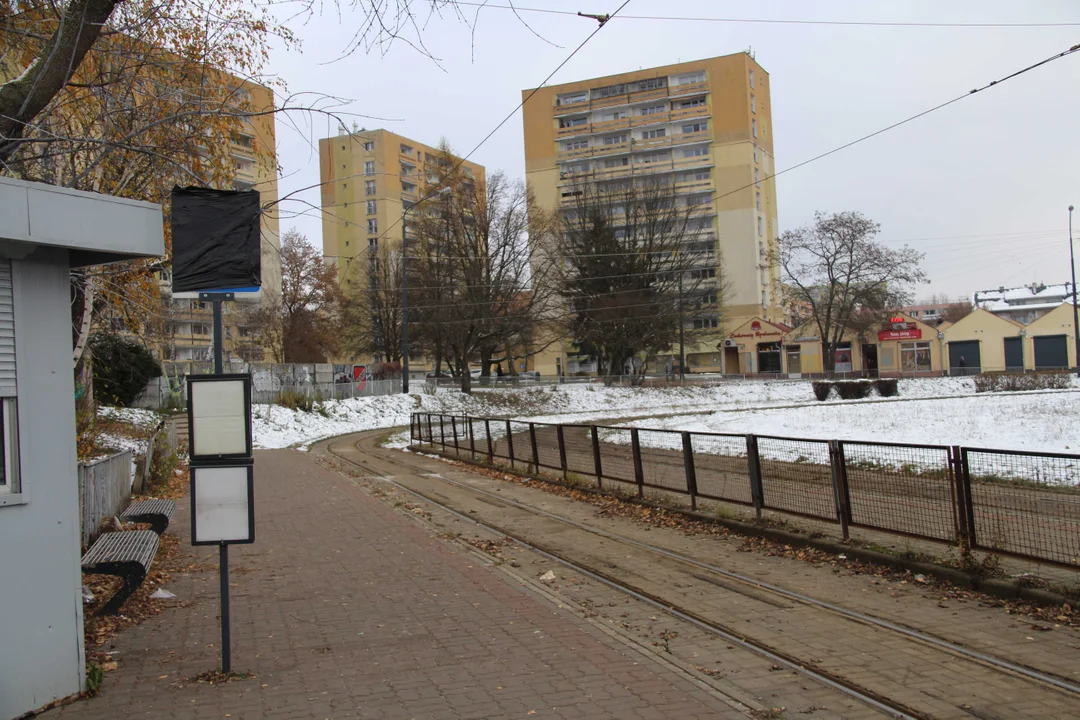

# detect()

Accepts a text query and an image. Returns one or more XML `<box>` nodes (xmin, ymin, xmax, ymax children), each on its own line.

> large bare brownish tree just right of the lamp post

<box><xmin>407</xmin><ymin>147</ymin><xmax>554</xmax><ymax>392</ymax></box>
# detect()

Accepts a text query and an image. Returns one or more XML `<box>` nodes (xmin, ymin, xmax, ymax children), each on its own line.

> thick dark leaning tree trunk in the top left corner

<box><xmin>0</xmin><ymin>0</ymin><xmax>119</xmax><ymax>162</ymax></box>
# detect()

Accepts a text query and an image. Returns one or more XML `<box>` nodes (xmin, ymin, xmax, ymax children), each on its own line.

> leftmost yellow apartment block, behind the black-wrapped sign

<box><xmin>162</xmin><ymin>76</ymin><xmax>281</xmax><ymax>362</ymax></box>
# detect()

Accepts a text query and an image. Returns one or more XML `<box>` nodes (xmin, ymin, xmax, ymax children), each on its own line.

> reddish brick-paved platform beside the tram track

<box><xmin>48</xmin><ymin>450</ymin><xmax>743</xmax><ymax>719</ymax></box>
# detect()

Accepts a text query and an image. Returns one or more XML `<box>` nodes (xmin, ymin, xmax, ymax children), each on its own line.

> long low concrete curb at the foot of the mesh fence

<box><xmin>408</xmin><ymin>446</ymin><xmax>1080</xmax><ymax>607</ymax></box>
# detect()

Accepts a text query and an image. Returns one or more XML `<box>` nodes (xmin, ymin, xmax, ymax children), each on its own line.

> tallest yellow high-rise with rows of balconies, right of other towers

<box><xmin>523</xmin><ymin>53</ymin><xmax>782</xmax><ymax>375</ymax></box>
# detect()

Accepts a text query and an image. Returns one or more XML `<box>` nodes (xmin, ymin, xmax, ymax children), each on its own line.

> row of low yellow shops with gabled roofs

<box><xmin>687</xmin><ymin>303</ymin><xmax>1076</xmax><ymax>377</ymax></box>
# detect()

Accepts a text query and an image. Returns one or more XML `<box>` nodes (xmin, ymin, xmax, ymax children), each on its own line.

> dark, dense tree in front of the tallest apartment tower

<box><xmin>558</xmin><ymin>179</ymin><xmax>724</xmax><ymax>380</ymax></box>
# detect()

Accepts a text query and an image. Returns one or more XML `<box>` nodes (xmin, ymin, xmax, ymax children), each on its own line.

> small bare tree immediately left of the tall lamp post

<box><xmin>343</xmin><ymin>246</ymin><xmax>402</xmax><ymax>363</ymax></box>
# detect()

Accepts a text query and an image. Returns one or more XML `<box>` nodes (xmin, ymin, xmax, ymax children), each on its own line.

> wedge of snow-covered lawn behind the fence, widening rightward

<box><xmin>629</xmin><ymin>391</ymin><xmax>1080</xmax><ymax>452</ymax></box>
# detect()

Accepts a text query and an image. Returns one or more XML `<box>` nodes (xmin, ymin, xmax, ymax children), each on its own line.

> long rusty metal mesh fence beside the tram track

<box><xmin>410</xmin><ymin>412</ymin><xmax>1080</xmax><ymax>568</ymax></box>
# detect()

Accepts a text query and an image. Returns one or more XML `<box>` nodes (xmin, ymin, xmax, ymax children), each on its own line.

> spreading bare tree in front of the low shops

<box><xmin>771</xmin><ymin>212</ymin><xmax>927</xmax><ymax>371</ymax></box>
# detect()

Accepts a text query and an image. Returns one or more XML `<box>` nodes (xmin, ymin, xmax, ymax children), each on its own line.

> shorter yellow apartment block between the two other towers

<box><xmin>319</xmin><ymin>128</ymin><xmax>485</xmax><ymax>375</ymax></box>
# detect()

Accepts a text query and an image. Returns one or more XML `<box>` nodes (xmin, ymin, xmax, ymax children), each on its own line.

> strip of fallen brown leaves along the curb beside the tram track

<box><xmin>425</xmin><ymin>457</ymin><xmax>1080</xmax><ymax>631</ymax></box>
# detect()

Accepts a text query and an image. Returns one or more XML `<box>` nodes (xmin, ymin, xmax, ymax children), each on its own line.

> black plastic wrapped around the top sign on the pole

<box><xmin>173</xmin><ymin>188</ymin><xmax>262</xmax><ymax>293</ymax></box>
